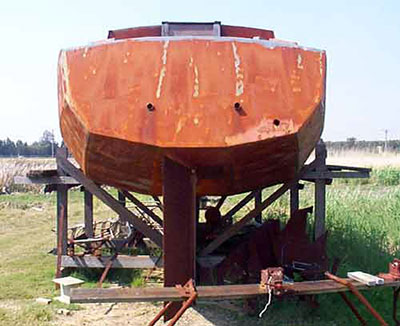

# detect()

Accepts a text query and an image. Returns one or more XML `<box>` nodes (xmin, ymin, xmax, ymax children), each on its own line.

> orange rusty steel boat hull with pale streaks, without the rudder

<box><xmin>59</xmin><ymin>32</ymin><xmax>326</xmax><ymax>195</ymax></box>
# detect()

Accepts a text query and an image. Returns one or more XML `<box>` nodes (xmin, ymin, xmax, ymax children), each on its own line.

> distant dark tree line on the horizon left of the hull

<box><xmin>0</xmin><ymin>130</ymin><xmax>59</xmax><ymax>157</ymax></box>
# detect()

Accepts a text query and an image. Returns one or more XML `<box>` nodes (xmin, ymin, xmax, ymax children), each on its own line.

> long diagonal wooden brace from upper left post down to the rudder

<box><xmin>57</xmin><ymin>156</ymin><xmax>162</xmax><ymax>247</ymax></box>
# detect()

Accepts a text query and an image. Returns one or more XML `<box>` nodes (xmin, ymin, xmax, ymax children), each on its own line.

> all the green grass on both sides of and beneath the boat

<box><xmin>0</xmin><ymin>167</ymin><xmax>400</xmax><ymax>325</ymax></box>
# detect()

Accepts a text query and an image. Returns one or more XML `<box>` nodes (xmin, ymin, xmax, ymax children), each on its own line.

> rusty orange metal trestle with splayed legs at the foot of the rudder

<box><xmin>149</xmin><ymin>279</ymin><xmax>198</xmax><ymax>326</ymax></box>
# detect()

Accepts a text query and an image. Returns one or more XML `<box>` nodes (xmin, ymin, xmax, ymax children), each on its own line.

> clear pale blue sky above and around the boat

<box><xmin>0</xmin><ymin>0</ymin><xmax>400</xmax><ymax>143</ymax></box>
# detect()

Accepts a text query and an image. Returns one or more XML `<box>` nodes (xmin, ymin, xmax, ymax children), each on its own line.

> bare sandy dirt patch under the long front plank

<box><xmin>53</xmin><ymin>303</ymin><xmax>242</xmax><ymax>326</ymax></box>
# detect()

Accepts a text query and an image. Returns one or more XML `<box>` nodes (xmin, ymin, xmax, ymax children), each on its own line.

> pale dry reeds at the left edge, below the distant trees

<box><xmin>0</xmin><ymin>158</ymin><xmax>55</xmax><ymax>193</ymax></box>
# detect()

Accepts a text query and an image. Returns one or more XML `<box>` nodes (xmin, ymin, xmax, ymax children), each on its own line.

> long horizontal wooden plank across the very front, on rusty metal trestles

<box><xmin>70</xmin><ymin>279</ymin><xmax>400</xmax><ymax>303</ymax></box>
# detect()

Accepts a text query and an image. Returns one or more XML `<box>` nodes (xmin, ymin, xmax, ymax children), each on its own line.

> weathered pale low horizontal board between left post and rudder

<box><xmin>61</xmin><ymin>255</ymin><xmax>163</xmax><ymax>269</ymax></box>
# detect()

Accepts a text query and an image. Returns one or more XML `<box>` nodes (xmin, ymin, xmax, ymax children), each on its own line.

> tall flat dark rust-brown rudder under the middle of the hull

<box><xmin>163</xmin><ymin>158</ymin><xmax>197</xmax><ymax>320</ymax></box>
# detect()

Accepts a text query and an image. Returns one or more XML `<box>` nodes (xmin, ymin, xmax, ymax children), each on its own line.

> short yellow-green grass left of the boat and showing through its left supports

<box><xmin>0</xmin><ymin>191</ymin><xmax>143</xmax><ymax>326</ymax></box>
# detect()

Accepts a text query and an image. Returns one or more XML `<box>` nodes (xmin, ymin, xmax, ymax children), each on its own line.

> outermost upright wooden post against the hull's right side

<box><xmin>314</xmin><ymin>139</ymin><xmax>327</xmax><ymax>239</ymax></box>
